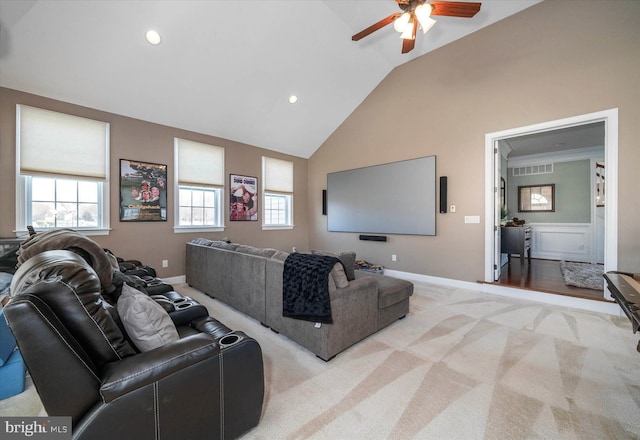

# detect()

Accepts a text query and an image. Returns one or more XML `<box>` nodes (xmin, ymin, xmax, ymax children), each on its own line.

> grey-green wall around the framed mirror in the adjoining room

<box><xmin>507</xmin><ymin>160</ymin><xmax>591</xmax><ymax>223</ymax></box>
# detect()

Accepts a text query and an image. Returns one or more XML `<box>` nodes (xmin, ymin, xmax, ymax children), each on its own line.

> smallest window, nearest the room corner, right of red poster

<box><xmin>262</xmin><ymin>156</ymin><xmax>293</xmax><ymax>229</ymax></box>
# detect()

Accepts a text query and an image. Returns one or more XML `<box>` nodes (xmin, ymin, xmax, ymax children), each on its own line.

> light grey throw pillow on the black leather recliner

<box><xmin>116</xmin><ymin>284</ymin><xmax>179</xmax><ymax>351</ymax></box>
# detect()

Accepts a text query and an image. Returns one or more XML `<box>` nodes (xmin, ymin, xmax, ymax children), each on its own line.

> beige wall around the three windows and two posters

<box><xmin>0</xmin><ymin>88</ymin><xmax>308</xmax><ymax>277</ymax></box>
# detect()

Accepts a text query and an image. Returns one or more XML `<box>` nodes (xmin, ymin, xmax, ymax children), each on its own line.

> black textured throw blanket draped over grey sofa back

<box><xmin>282</xmin><ymin>252</ymin><xmax>339</xmax><ymax>324</ymax></box>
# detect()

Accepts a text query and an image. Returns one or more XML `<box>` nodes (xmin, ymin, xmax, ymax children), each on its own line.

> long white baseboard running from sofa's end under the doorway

<box><xmin>384</xmin><ymin>269</ymin><xmax>623</xmax><ymax>316</ymax></box>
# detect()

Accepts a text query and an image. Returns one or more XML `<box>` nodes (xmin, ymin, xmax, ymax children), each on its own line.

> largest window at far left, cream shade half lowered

<box><xmin>16</xmin><ymin>104</ymin><xmax>109</xmax><ymax>234</ymax></box>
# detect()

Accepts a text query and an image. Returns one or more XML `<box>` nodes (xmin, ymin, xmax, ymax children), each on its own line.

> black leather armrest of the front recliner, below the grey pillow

<box><xmin>100</xmin><ymin>334</ymin><xmax>220</xmax><ymax>403</ymax></box>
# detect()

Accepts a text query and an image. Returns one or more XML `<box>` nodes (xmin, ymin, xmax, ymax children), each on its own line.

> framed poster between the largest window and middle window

<box><xmin>120</xmin><ymin>159</ymin><xmax>167</xmax><ymax>222</ymax></box>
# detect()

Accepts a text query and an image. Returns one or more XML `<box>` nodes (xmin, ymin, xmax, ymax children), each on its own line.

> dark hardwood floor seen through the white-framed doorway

<box><xmin>493</xmin><ymin>257</ymin><xmax>612</xmax><ymax>302</ymax></box>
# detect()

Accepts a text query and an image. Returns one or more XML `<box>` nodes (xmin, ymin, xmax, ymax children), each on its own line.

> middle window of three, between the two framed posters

<box><xmin>174</xmin><ymin>138</ymin><xmax>224</xmax><ymax>232</ymax></box>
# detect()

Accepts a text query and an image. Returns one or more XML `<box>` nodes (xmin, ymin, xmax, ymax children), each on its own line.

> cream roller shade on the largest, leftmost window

<box><xmin>16</xmin><ymin>105</ymin><xmax>109</xmax><ymax>180</ymax></box>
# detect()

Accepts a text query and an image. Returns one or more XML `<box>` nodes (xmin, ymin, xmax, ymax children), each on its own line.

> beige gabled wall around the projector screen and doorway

<box><xmin>309</xmin><ymin>0</ymin><xmax>640</xmax><ymax>281</ymax></box>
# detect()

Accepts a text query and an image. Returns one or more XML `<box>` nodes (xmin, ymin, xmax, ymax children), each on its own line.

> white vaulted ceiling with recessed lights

<box><xmin>0</xmin><ymin>0</ymin><xmax>540</xmax><ymax>158</ymax></box>
